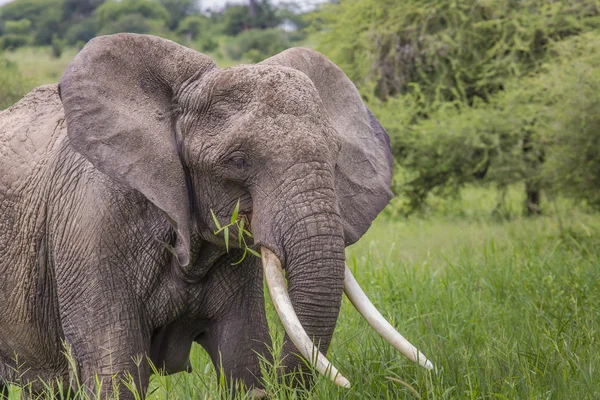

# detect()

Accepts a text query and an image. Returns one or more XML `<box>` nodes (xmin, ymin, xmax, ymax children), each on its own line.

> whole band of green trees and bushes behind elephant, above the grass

<box><xmin>0</xmin><ymin>0</ymin><xmax>600</xmax><ymax>215</ymax></box>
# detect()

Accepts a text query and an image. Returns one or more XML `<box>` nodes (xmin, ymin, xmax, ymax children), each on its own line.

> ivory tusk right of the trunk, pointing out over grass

<box><xmin>344</xmin><ymin>265</ymin><xmax>433</xmax><ymax>370</ymax></box>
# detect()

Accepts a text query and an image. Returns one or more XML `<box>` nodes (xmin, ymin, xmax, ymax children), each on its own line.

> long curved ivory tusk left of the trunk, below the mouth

<box><xmin>260</xmin><ymin>247</ymin><xmax>350</xmax><ymax>388</ymax></box>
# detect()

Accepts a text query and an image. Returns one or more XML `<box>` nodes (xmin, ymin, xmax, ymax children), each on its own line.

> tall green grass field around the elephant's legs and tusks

<box><xmin>5</xmin><ymin>190</ymin><xmax>600</xmax><ymax>399</ymax></box>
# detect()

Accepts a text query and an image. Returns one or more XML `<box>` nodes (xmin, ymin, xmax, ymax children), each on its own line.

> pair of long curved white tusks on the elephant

<box><xmin>260</xmin><ymin>246</ymin><xmax>433</xmax><ymax>388</ymax></box>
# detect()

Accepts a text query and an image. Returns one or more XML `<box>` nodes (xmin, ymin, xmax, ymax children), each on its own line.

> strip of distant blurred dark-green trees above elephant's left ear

<box><xmin>0</xmin><ymin>0</ymin><xmax>307</xmax><ymax>59</ymax></box>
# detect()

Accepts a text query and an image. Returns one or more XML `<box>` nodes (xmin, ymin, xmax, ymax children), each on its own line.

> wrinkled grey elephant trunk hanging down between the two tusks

<box><xmin>252</xmin><ymin>177</ymin><xmax>349</xmax><ymax>386</ymax></box>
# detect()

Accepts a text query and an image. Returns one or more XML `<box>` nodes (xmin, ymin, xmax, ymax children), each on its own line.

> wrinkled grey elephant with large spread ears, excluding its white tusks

<box><xmin>0</xmin><ymin>34</ymin><xmax>392</xmax><ymax>396</ymax></box>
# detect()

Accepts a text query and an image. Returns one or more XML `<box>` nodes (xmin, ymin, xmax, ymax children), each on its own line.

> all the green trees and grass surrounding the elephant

<box><xmin>0</xmin><ymin>0</ymin><xmax>600</xmax><ymax>400</ymax></box>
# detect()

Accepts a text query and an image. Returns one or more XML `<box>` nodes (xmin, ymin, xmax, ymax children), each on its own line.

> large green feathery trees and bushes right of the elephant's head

<box><xmin>317</xmin><ymin>0</ymin><xmax>600</xmax><ymax>215</ymax></box>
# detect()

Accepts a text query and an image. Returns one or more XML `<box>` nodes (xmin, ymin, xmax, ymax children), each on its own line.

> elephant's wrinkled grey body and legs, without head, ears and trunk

<box><xmin>0</xmin><ymin>85</ymin><xmax>269</xmax><ymax>394</ymax></box>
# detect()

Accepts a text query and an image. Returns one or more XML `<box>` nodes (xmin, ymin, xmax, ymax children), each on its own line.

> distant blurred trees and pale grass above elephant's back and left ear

<box><xmin>0</xmin><ymin>0</ymin><xmax>308</xmax><ymax>110</ymax></box>
